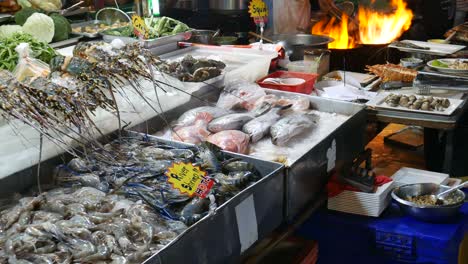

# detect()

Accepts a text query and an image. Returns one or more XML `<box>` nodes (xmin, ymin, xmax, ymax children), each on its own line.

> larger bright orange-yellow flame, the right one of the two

<box><xmin>358</xmin><ymin>0</ymin><xmax>413</xmax><ymax>44</ymax></box>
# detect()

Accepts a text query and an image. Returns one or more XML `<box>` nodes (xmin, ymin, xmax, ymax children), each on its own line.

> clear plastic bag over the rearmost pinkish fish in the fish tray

<box><xmin>216</xmin><ymin>80</ymin><xmax>266</xmax><ymax>110</ymax></box>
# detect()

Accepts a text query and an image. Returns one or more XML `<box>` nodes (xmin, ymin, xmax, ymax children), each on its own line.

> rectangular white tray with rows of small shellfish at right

<box><xmin>366</xmin><ymin>92</ymin><xmax>464</xmax><ymax>116</ymax></box>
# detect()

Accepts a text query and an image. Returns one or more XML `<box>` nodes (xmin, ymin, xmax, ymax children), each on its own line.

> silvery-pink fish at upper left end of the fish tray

<box><xmin>176</xmin><ymin>106</ymin><xmax>229</xmax><ymax>127</ymax></box>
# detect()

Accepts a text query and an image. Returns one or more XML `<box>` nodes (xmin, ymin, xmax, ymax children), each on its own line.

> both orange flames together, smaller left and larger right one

<box><xmin>312</xmin><ymin>0</ymin><xmax>413</xmax><ymax>49</ymax></box>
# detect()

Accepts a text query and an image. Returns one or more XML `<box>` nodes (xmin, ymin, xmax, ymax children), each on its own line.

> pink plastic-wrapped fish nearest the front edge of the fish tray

<box><xmin>208</xmin><ymin>130</ymin><xmax>250</xmax><ymax>154</ymax></box>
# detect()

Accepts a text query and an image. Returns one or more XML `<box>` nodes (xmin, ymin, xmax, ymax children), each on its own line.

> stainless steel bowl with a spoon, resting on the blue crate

<box><xmin>392</xmin><ymin>183</ymin><xmax>465</xmax><ymax>222</ymax></box>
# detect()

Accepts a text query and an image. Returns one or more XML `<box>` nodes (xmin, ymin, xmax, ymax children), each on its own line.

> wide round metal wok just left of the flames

<box><xmin>269</xmin><ymin>34</ymin><xmax>334</xmax><ymax>61</ymax></box>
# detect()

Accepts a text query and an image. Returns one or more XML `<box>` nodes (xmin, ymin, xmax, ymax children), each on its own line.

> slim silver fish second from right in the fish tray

<box><xmin>242</xmin><ymin>107</ymin><xmax>282</xmax><ymax>143</ymax></box>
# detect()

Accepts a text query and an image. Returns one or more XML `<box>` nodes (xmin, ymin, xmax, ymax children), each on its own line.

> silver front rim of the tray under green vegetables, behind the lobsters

<box><xmin>100</xmin><ymin>30</ymin><xmax>193</xmax><ymax>49</ymax></box>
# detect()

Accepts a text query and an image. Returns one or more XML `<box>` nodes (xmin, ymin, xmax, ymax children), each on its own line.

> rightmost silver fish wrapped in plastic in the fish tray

<box><xmin>270</xmin><ymin>114</ymin><xmax>318</xmax><ymax>146</ymax></box>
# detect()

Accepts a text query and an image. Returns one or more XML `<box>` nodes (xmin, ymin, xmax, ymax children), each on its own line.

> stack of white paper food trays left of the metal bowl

<box><xmin>328</xmin><ymin>181</ymin><xmax>394</xmax><ymax>217</ymax></box>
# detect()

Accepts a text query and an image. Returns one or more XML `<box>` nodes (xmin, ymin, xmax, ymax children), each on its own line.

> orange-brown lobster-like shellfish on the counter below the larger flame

<box><xmin>366</xmin><ymin>63</ymin><xmax>418</xmax><ymax>82</ymax></box>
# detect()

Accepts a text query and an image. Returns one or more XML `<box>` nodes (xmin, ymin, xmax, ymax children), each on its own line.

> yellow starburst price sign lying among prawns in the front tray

<box><xmin>166</xmin><ymin>162</ymin><xmax>214</xmax><ymax>198</ymax></box>
